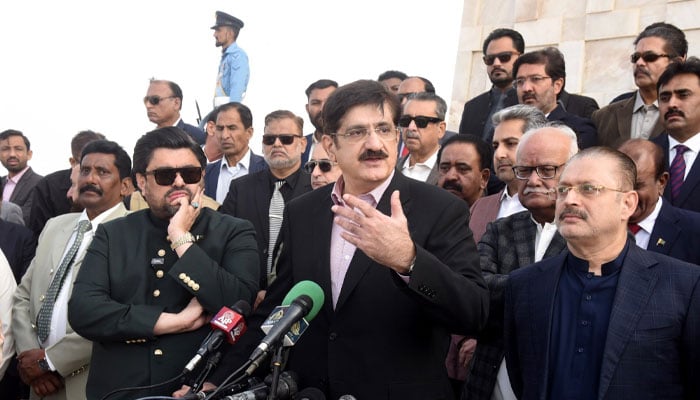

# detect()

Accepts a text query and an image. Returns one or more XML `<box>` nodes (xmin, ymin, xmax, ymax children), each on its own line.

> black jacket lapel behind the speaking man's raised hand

<box><xmin>336</xmin><ymin>176</ymin><xmax>411</xmax><ymax>311</ymax></box>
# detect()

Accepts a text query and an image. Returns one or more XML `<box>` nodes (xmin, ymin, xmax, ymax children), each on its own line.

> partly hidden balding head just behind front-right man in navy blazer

<box><xmin>618</xmin><ymin>139</ymin><xmax>669</xmax><ymax>223</ymax></box>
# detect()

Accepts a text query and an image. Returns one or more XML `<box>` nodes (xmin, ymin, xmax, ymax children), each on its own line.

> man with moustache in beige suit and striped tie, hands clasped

<box><xmin>12</xmin><ymin>140</ymin><xmax>131</xmax><ymax>400</ymax></box>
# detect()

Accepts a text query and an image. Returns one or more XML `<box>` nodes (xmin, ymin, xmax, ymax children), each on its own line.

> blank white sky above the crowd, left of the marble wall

<box><xmin>0</xmin><ymin>0</ymin><xmax>463</xmax><ymax>175</ymax></box>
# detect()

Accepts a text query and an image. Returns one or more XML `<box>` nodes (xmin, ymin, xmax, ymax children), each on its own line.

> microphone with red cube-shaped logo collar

<box><xmin>183</xmin><ymin>300</ymin><xmax>250</xmax><ymax>373</ymax></box>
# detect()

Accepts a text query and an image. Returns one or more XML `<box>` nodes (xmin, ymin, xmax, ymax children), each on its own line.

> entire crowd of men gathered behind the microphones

<box><xmin>0</xmin><ymin>17</ymin><xmax>700</xmax><ymax>400</ymax></box>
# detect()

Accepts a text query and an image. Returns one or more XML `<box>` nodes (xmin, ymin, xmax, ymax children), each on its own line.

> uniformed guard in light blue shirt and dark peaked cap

<box><xmin>211</xmin><ymin>11</ymin><xmax>250</xmax><ymax>107</ymax></box>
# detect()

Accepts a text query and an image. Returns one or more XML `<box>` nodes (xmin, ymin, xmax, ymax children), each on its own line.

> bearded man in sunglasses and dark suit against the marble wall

<box><xmin>459</xmin><ymin>28</ymin><xmax>525</xmax><ymax>143</ymax></box>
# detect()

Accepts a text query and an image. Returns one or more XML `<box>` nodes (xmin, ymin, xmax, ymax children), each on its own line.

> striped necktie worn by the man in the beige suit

<box><xmin>36</xmin><ymin>220</ymin><xmax>92</xmax><ymax>343</ymax></box>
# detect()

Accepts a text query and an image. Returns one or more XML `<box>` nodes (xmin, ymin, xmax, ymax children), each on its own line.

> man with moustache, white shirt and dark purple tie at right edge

<box><xmin>653</xmin><ymin>57</ymin><xmax>700</xmax><ymax>212</ymax></box>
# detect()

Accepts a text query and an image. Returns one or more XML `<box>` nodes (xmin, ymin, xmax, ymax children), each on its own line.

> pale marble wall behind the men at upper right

<box><xmin>448</xmin><ymin>0</ymin><xmax>700</xmax><ymax>131</ymax></box>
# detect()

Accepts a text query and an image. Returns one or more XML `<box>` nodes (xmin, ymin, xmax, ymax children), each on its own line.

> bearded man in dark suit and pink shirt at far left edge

<box><xmin>0</xmin><ymin>129</ymin><xmax>43</xmax><ymax>226</ymax></box>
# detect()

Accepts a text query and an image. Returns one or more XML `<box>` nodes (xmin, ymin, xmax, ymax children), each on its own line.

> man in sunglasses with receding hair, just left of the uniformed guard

<box><xmin>143</xmin><ymin>79</ymin><xmax>206</xmax><ymax>145</ymax></box>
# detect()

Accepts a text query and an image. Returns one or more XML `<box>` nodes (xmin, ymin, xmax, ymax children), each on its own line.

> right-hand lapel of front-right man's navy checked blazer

<box><xmin>598</xmin><ymin>243</ymin><xmax>658</xmax><ymax>399</ymax></box>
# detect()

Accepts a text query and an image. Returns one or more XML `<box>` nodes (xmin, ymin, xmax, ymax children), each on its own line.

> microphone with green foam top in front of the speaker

<box><xmin>247</xmin><ymin>281</ymin><xmax>325</xmax><ymax>368</ymax></box>
